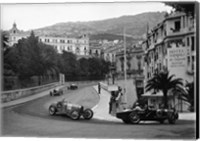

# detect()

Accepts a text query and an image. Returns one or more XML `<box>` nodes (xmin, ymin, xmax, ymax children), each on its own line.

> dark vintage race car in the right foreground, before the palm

<box><xmin>116</xmin><ymin>109</ymin><xmax>178</xmax><ymax>124</ymax></box>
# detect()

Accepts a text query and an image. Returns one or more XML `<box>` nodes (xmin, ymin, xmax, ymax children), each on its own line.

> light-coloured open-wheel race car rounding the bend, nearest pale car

<box><xmin>49</xmin><ymin>99</ymin><xmax>93</xmax><ymax>120</ymax></box>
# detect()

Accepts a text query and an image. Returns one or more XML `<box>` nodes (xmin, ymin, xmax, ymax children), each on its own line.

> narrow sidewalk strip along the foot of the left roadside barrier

<box><xmin>0</xmin><ymin>86</ymin><xmax>63</xmax><ymax>108</ymax></box>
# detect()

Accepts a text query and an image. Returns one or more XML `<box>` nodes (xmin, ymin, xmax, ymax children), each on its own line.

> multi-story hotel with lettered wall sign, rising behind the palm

<box><xmin>142</xmin><ymin>12</ymin><xmax>196</xmax><ymax>110</ymax></box>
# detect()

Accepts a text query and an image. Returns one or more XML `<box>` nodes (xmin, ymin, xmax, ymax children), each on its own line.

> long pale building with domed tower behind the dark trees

<box><xmin>9</xmin><ymin>23</ymin><xmax>89</xmax><ymax>56</ymax></box>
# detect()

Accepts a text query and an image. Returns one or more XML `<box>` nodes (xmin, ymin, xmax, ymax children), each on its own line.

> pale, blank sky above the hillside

<box><xmin>0</xmin><ymin>2</ymin><xmax>172</xmax><ymax>31</ymax></box>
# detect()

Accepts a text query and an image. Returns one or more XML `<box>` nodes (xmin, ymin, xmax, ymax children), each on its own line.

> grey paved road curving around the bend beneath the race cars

<box><xmin>2</xmin><ymin>82</ymin><xmax>195</xmax><ymax>139</ymax></box>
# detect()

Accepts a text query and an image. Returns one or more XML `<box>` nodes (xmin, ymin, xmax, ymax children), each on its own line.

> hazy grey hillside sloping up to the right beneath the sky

<box><xmin>31</xmin><ymin>12</ymin><xmax>165</xmax><ymax>39</ymax></box>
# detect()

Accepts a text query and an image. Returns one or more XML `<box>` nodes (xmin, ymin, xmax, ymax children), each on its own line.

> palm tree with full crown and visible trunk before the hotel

<box><xmin>146</xmin><ymin>71</ymin><xmax>183</xmax><ymax>108</ymax></box>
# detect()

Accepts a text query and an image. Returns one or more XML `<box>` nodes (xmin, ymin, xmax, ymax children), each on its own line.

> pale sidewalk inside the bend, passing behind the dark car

<box><xmin>92</xmin><ymin>86</ymin><xmax>196</xmax><ymax>122</ymax></box>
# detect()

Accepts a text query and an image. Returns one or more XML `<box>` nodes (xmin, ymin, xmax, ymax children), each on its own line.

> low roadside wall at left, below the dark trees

<box><xmin>1</xmin><ymin>82</ymin><xmax>60</xmax><ymax>103</ymax></box>
